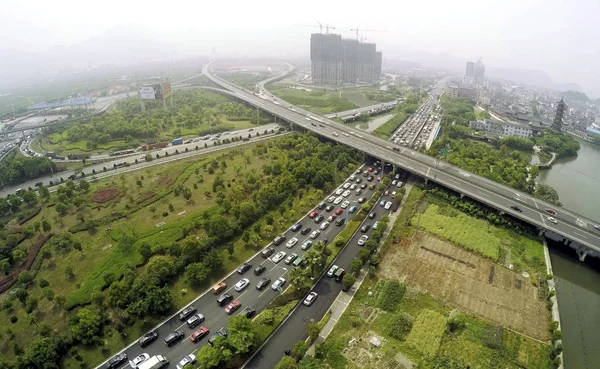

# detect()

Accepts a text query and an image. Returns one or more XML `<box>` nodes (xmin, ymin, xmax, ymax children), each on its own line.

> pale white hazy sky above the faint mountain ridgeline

<box><xmin>0</xmin><ymin>0</ymin><xmax>600</xmax><ymax>91</ymax></box>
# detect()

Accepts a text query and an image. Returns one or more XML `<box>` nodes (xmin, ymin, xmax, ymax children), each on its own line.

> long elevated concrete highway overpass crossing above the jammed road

<box><xmin>203</xmin><ymin>65</ymin><xmax>600</xmax><ymax>253</ymax></box>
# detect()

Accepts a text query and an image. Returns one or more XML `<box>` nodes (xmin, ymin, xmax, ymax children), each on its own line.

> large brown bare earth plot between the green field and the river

<box><xmin>379</xmin><ymin>233</ymin><xmax>550</xmax><ymax>341</ymax></box>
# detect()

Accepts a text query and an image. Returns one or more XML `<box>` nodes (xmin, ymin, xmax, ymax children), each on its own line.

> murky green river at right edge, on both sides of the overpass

<box><xmin>538</xmin><ymin>140</ymin><xmax>600</xmax><ymax>369</ymax></box>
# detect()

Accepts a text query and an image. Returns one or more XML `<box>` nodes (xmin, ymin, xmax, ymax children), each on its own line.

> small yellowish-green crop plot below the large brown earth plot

<box><xmin>406</xmin><ymin>310</ymin><xmax>446</xmax><ymax>356</ymax></box>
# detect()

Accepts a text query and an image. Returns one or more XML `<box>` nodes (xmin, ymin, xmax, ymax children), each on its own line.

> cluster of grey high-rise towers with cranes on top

<box><xmin>310</xmin><ymin>33</ymin><xmax>382</xmax><ymax>85</ymax></box>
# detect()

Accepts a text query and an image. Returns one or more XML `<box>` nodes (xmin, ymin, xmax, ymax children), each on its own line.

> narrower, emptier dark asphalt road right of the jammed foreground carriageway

<box><xmin>243</xmin><ymin>166</ymin><xmax>409</xmax><ymax>369</ymax></box>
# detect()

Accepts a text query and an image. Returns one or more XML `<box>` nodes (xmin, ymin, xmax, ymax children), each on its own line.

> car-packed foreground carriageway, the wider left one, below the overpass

<box><xmin>98</xmin><ymin>166</ymin><xmax>377</xmax><ymax>368</ymax></box>
